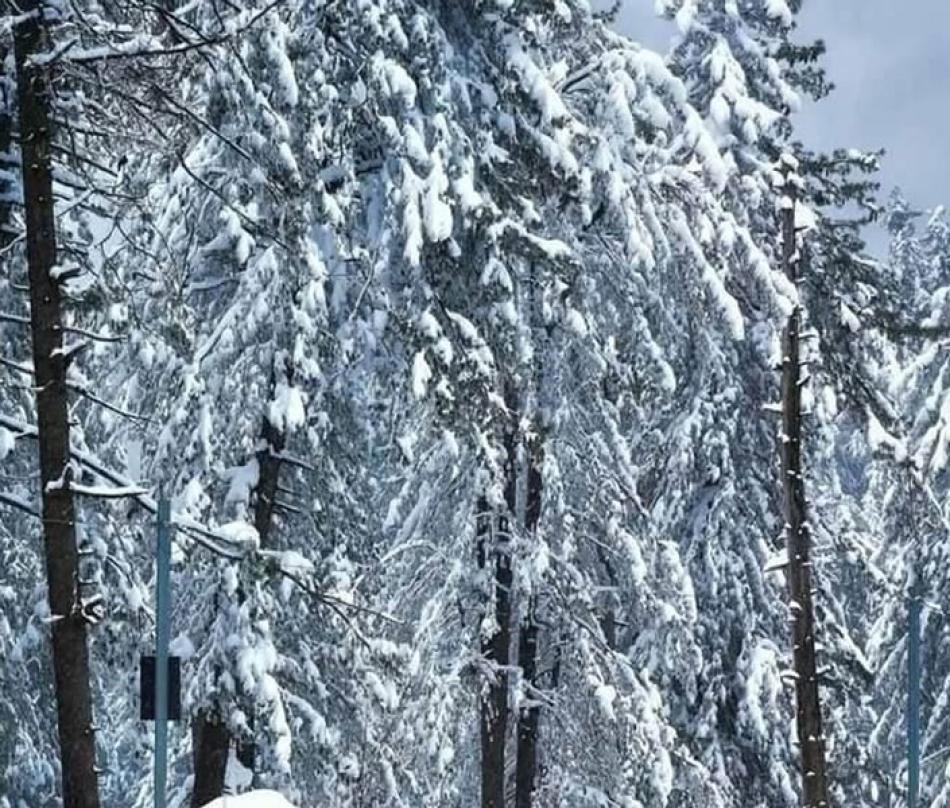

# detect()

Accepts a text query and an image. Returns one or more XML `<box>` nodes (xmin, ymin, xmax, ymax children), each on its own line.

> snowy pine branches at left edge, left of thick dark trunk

<box><xmin>0</xmin><ymin>25</ymin><xmax>61</xmax><ymax>808</ymax></box>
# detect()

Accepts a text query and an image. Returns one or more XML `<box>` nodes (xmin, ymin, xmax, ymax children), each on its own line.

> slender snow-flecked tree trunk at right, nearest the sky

<box><xmin>780</xmin><ymin>159</ymin><xmax>828</xmax><ymax>808</ymax></box>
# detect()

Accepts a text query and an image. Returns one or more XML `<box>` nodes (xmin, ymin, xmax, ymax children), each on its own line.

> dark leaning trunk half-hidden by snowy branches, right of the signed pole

<box><xmin>192</xmin><ymin>396</ymin><xmax>285</xmax><ymax>808</ymax></box>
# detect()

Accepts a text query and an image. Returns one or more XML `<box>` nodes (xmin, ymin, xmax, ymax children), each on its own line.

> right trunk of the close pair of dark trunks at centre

<box><xmin>515</xmin><ymin>446</ymin><xmax>543</xmax><ymax>808</ymax></box>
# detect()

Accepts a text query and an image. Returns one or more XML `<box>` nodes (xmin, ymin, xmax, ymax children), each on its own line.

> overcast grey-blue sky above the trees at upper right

<box><xmin>619</xmin><ymin>0</ymin><xmax>950</xmax><ymax>254</ymax></box>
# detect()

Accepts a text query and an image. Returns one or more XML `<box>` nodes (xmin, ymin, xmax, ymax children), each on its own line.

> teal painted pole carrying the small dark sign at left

<box><xmin>155</xmin><ymin>497</ymin><xmax>172</xmax><ymax>808</ymax></box>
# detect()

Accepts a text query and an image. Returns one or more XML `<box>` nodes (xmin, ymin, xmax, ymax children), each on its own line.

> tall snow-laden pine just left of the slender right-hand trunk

<box><xmin>644</xmin><ymin>1</ymin><xmax>820</xmax><ymax>806</ymax></box>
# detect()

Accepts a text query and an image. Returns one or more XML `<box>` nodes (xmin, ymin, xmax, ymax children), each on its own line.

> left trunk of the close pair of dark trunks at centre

<box><xmin>477</xmin><ymin>408</ymin><xmax>518</xmax><ymax>808</ymax></box>
